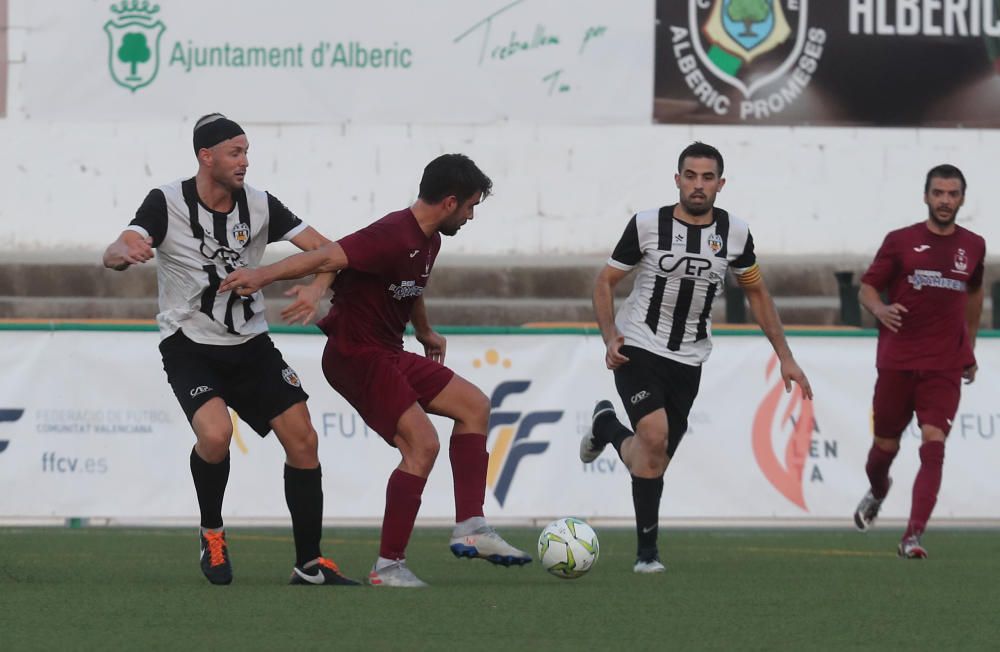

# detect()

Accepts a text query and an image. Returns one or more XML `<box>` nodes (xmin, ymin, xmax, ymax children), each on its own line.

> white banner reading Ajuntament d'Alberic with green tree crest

<box><xmin>23</xmin><ymin>0</ymin><xmax>655</xmax><ymax>124</ymax></box>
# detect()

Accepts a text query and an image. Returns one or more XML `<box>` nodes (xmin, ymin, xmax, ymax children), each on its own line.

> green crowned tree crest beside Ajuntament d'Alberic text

<box><xmin>104</xmin><ymin>0</ymin><xmax>167</xmax><ymax>93</ymax></box>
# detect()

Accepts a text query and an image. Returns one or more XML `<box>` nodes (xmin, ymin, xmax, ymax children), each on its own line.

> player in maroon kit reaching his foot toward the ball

<box><xmin>219</xmin><ymin>154</ymin><xmax>531</xmax><ymax>587</ymax></box>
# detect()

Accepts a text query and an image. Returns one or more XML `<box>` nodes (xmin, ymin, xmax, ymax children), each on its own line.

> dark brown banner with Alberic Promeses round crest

<box><xmin>653</xmin><ymin>0</ymin><xmax>1000</xmax><ymax>127</ymax></box>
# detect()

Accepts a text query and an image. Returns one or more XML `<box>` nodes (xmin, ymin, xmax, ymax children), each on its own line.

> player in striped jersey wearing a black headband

<box><xmin>104</xmin><ymin>113</ymin><xmax>358</xmax><ymax>585</ymax></box>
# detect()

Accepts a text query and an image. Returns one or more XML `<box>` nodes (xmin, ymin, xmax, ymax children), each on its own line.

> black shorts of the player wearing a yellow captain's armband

<box><xmin>614</xmin><ymin>346</ymin><xmax>701</xmax><ymax>458</ymax></box>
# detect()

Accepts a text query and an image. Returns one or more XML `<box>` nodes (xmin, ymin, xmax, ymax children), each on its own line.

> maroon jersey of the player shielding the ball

<box><xmin>318</xmin><ymin>208</ymin><xmax>441</xmax><ymax>350</ymax></box>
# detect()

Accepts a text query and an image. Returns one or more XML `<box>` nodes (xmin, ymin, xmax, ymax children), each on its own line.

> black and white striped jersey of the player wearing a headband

<box><xmin>128</xmin><ymin>178</ymin><xmax>306</xmax><ymax>345</ymax></box>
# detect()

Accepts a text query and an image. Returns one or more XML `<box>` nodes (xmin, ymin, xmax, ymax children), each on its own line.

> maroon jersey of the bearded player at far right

<box><xmin>861</xmin><ymin>222</ymin><xmax>986</xmax><ymax>370</ymax></box>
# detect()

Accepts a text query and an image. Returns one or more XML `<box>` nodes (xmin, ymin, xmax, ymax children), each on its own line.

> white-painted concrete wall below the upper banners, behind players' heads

<box><xmin>0</xmin><ymin>2</ymin><xmax>1000</xmax><ymax>260</ymax></box>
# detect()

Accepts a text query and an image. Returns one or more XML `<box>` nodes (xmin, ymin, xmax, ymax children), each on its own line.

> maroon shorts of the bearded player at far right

<box><xmin>872</xmin><ymin>369</ymin><xmax>962</xmax><ymax>439</ymax></box>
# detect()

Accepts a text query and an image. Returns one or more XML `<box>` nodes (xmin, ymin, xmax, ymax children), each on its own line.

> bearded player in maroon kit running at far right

<box><xmin>854</xmin><ymin>165</ymin><xmax>986</xmax><ymax>559</ymax></box>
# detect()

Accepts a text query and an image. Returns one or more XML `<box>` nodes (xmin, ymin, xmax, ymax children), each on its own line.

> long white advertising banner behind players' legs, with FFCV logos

<box><xmin>0</xmin><ymin>331</ymin><xmax>1000</xmax><ymax>524</ymax></box>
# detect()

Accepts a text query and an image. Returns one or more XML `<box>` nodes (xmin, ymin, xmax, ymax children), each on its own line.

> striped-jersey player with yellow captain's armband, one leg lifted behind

<box><xmin>580</xmin><ymin>142</ymin><xmax>812</xmax><ymax>573</ymax></box>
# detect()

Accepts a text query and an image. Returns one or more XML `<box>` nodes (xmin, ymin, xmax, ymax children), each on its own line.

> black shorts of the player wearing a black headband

<box><xmin>160</xmin><ymin>331</ymin><xmax>309</xmax><ymax>437</ymax></box>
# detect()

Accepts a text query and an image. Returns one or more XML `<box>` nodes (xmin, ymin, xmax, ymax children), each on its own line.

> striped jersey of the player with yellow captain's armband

<box><xmin>608</xmin><ymin>206</ymin><xmax>757</xmax><ymax>365</ymax></box>
